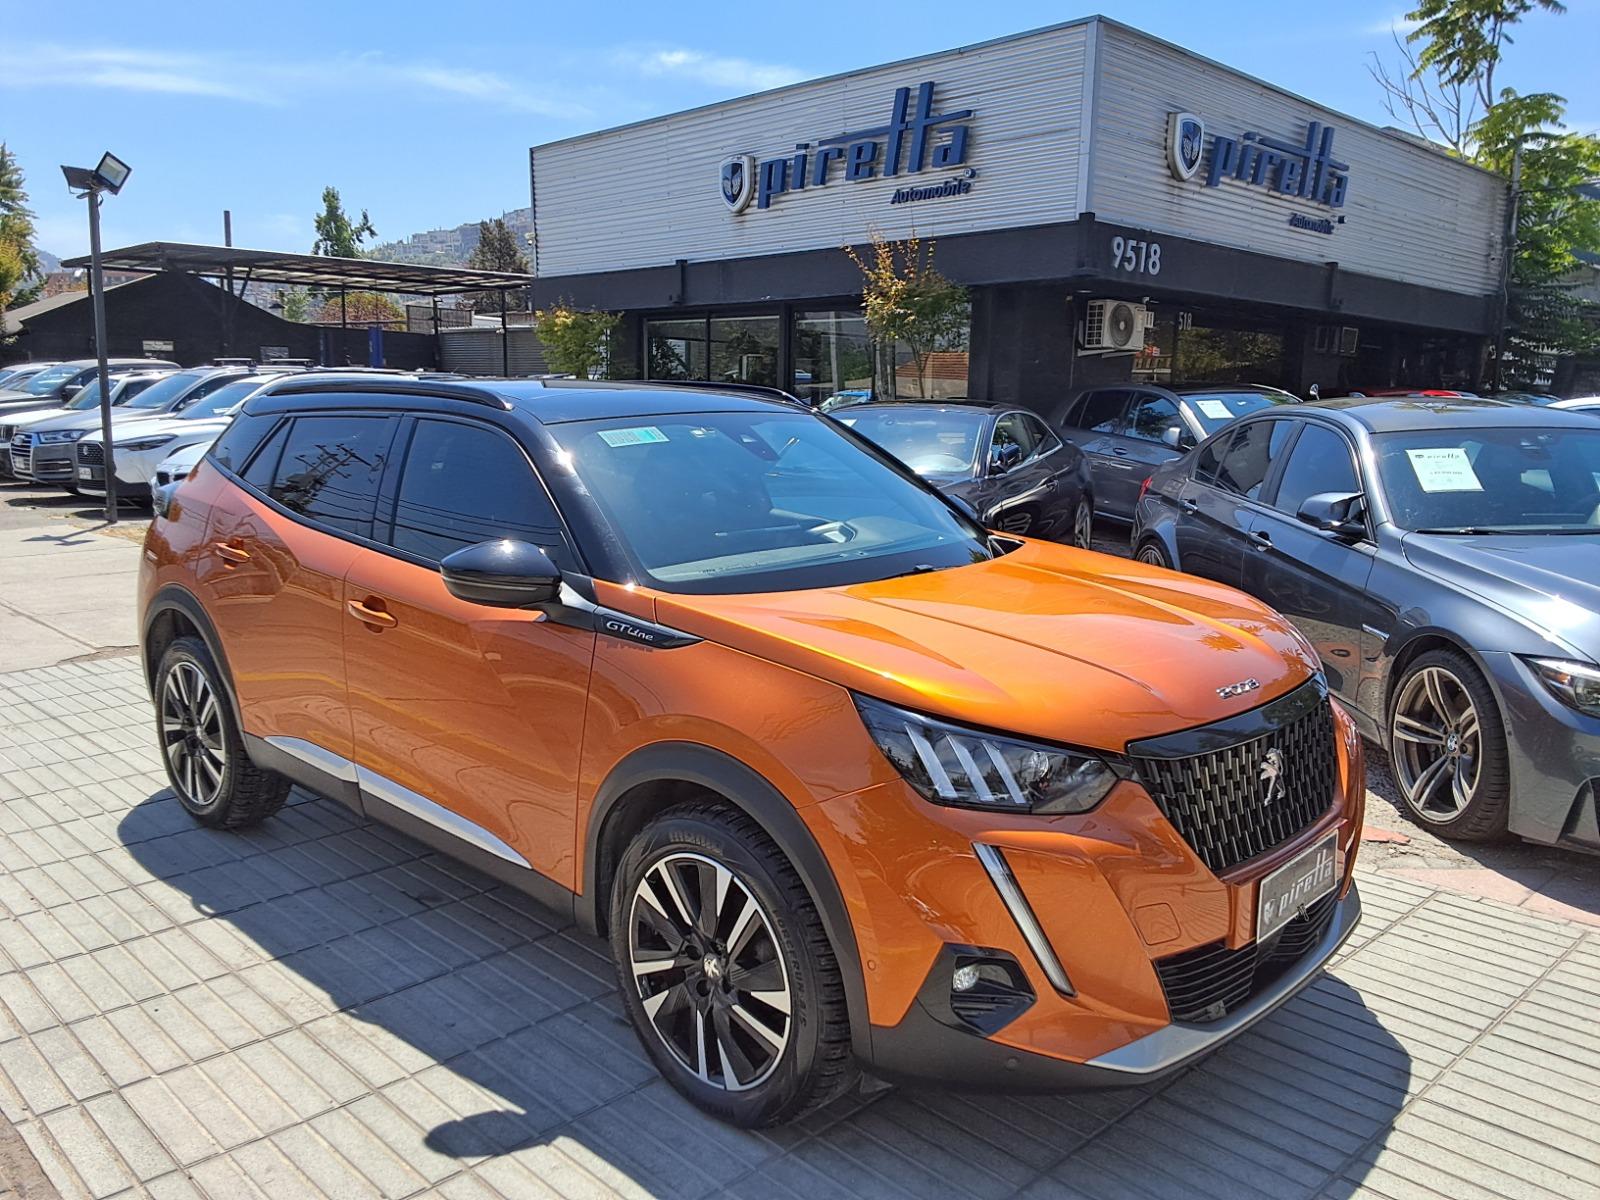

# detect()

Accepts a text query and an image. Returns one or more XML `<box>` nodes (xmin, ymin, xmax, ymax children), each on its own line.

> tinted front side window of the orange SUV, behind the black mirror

<box><xmin>389</xmin><ymin>421</ymin><xmax>562</xmax><ymax>562</ymax></box>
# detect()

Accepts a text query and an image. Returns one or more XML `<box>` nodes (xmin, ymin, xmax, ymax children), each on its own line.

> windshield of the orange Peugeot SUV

<box><xmin>549</xmin><ymin>411</ymin><xmax>990</xmax><ymax>592</ymax></box>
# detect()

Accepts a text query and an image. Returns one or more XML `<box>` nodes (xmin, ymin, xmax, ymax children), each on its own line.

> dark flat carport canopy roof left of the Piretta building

<box><xmin>61</xmin><ymin>242</ymin><xmax>533</xmax><ymax>296</ymax></box>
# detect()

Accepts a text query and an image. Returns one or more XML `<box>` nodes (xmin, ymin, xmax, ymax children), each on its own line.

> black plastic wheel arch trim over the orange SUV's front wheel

<box><xmin>576</xmin><ymin>742</ymin><xmax>872</xmax><ymax>1059</ymax></box>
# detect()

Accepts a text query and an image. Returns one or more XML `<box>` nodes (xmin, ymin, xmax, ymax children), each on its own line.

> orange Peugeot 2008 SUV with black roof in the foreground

<box><xmin>139</xmin><ymin>376</ymin><xmax>1363</xmax><ymax>1125</ymax></box>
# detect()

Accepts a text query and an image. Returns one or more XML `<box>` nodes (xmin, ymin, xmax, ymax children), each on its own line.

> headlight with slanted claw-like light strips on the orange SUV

<box><xmin>854</xmin><ymin>696</ymin><xmax>1118</xmax><ymax>813</ymax></box>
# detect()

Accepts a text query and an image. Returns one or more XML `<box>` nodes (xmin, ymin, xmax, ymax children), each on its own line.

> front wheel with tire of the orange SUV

<box><xmin>610</xmin><ymin>802</ymin><xmax>856</xmax><ymax>1128</ymax></box>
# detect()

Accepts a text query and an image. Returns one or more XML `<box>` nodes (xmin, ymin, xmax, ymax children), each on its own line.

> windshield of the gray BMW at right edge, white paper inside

<box><xmin>1373</xmin><ymin>429</ymin><xmax>1600</xmax><ymax>533</ymax></box>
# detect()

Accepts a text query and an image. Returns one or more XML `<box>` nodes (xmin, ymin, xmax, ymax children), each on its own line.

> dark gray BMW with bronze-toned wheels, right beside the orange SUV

<box><xmin>1133</xmin><ymin>398</ymin><xmax>1600</xmax><ymax>850</ymax></box>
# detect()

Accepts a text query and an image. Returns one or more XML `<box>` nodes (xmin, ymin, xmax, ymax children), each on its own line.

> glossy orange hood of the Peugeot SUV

<box><xmin>654</xmin><ymin>541</ymin><xmax>1317</xmax><ymax>752</ymax></box>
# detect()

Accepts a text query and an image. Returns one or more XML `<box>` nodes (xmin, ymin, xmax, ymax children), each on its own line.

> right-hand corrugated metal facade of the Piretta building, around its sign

<box><xmin>1088</xmin><ymin>22</ymin><xmax>1506</xmax><ymax>294</ymax></box>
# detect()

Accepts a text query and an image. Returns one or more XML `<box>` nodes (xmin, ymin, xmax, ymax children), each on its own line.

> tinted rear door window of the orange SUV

<box><xmin>267</xmin><ymin>416</ymin><xmax>394</xmax><ymax>538</ymax></box>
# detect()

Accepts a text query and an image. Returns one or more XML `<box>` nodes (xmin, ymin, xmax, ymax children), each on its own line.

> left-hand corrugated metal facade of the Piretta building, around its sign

<box><xmin>533</xmin><ymin>22</ymin><xmax>1091</xmax><ymax>275</ymax></box>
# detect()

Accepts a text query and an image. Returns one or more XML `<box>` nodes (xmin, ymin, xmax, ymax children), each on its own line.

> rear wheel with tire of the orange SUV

<box><xmin>155</xmin><ymin>637</ymin><xmax>290</xmax><ymax>829</ymax></box>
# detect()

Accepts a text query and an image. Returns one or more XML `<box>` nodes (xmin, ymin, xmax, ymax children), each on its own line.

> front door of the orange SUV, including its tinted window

<box><xmin>342</xmin><ymin>418</ymin><xmax>595</xmax><ymax>886</ymax></box>
